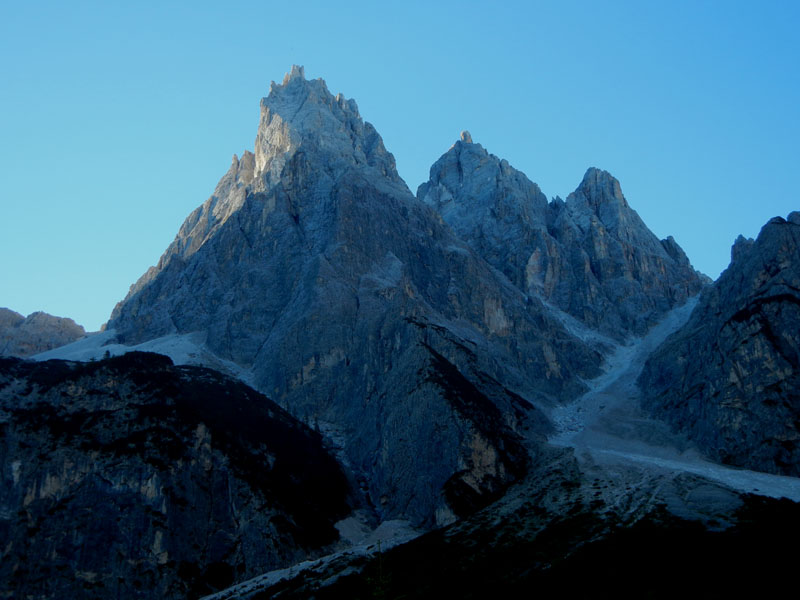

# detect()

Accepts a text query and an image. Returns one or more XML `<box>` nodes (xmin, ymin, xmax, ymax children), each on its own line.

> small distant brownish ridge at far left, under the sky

<box><xmin>0</xmin><ymin>308</ymin><xmax>86</xmax><ymax>357</ymax></box>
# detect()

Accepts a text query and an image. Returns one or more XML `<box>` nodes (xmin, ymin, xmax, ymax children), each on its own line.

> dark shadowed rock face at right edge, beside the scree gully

<box><xmin>639</xmin><ymin>212</ymin><xmax>800</xmax><ymax>476</ymax></box>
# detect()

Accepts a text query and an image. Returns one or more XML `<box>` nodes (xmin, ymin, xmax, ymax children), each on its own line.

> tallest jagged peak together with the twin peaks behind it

<box><xmin>108</xmin><ymin>68</ymin><xmax>702</xmax><ymax>524</ymax></box>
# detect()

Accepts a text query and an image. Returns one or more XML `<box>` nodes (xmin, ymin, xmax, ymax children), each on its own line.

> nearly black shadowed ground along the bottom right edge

<box><xmin>284</xmin><ymin>492</ymin><xmax>800</xmax><ymax>600</ymax></box>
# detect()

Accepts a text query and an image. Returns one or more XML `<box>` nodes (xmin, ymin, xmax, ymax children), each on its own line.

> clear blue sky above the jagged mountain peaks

<box><xmin>0</xmin><ymin>0</ymin><xmax>800</xmax><ymax>330</ymax></box>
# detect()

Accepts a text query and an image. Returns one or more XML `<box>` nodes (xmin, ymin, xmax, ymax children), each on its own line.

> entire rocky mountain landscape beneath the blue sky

<box><xmin>7</xmin><ymin>67</ymin><xmax>800</xmax><ymax>600</ymax></box>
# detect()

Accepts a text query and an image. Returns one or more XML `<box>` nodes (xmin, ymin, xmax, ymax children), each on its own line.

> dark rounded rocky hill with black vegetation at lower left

<box><xmin>0</xmin><ymin>353</ymin><xmax>351</xmax><ymax>599</ymax></box>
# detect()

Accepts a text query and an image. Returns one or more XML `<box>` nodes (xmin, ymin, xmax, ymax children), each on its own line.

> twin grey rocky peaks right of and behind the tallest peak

<box><xmin>417</xmin><ymin>138</ymin><xmax>706</xmax><ymax>340</ymax></box>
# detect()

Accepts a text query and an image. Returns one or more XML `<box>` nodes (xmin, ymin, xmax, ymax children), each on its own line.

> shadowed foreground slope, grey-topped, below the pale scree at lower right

<box><xmin>207</xmin><ymin>450</ymin><xmax>800</xmax><ymax>600</ymax></box>
